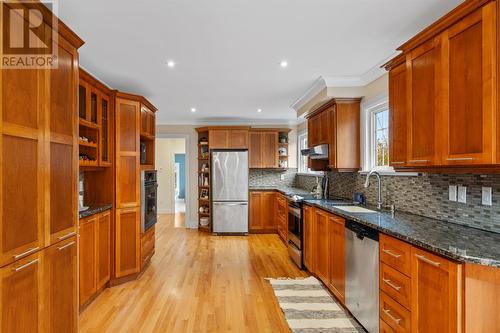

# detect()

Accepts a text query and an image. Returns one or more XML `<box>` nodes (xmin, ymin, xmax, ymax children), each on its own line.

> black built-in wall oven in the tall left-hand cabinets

<box><xmin>141</xmin><ymin>170</ymin><xmax>158</xmax><ymax>233</ymax></box>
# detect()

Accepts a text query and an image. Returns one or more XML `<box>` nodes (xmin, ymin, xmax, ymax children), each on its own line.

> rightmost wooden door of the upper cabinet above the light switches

<box><xmin>440</xmin><ymin>2</ymin><xmax>497</xmax><ymax>165</ymax></box>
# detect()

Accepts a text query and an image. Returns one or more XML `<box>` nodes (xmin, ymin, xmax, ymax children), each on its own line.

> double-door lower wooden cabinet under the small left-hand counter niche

<box><xmin>79</xmin><ymin>211</ymin><xmax>111</xmax><ymax>307</ymax></box>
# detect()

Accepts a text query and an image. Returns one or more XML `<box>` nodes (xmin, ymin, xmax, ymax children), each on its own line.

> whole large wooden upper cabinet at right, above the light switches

<box><xmin>386</xmin><ymin>1</ymin><xmax>500</xmax><ymax>172</ymax></box>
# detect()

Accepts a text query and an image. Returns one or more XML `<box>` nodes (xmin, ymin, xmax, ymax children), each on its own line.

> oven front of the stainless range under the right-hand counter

<box><xmin>288</xmin><ymin>200</ymin><xmax>303</xmax><ymax>269</ymax></box>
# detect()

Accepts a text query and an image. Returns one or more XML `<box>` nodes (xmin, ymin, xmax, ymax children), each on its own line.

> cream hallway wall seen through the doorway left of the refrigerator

<box><xmin>155</xmin><ymin>138</ymin><xmax>186</xmax><ymax>214</ymax></box>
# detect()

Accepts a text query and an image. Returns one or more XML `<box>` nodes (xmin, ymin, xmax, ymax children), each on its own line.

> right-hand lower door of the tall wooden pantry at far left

<box><xmin>44</xmin><ymin>237</ymin><xmax>78</xmax><ymax>332</ymax></box>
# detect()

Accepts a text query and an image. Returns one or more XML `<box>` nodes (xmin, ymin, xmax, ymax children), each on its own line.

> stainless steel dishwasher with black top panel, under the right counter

<box><xmin>345</xmin><ymin>221</ymin><xmax>379</xmax><ymax>333</ymax></box>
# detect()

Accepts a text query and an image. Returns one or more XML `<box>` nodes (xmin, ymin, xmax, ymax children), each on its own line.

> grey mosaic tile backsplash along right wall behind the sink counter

<box><xmin>294</xmin><ymin>172</ymin><xmax>500</xmax><ymax>233</ymax></box>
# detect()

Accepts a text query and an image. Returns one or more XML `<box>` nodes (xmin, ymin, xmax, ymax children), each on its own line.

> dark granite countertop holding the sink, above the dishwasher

<box><xmin>305</xmin><ymin>200</ymin><xmax>500</xmax><ymax>267</ymax></box>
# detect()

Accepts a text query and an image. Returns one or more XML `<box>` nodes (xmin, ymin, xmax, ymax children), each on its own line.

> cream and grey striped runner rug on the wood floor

<box><xmin>267</xmin><ymin>276</ymin><xmax>366</xmax><ymax>333</ymax></box>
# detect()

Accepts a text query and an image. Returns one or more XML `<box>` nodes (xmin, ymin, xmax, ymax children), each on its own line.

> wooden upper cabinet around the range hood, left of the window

<box><xmin>307</xmin><ymin>98</ymin><xmax>361</xmax><ymax>172</ymax></box>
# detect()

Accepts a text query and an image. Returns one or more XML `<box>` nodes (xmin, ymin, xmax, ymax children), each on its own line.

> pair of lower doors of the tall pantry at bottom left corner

<box><xmin>0</xmin><ymin>237</ymin><xmax>77</xmax><ymax>333</ymax></box>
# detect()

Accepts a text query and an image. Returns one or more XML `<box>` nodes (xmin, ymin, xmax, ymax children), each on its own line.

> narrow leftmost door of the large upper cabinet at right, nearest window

<box><xmin>389</xmin><ymin>57</ymin><xmax>407</xmax><ymax>167</ymax></box>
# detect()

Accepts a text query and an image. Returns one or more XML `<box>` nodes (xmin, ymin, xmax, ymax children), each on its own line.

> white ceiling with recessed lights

<box><xmin>59</xmin><ymin>0</ymin><xmax>462</xmax><ymax>124</ymax></box>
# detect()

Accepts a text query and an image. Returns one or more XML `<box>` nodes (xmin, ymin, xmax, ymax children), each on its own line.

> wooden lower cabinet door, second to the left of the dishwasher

<box><xmin>314</xmin><ymin>209</ymin><xmax>330</xmax><ymax>284</ymax></box>
